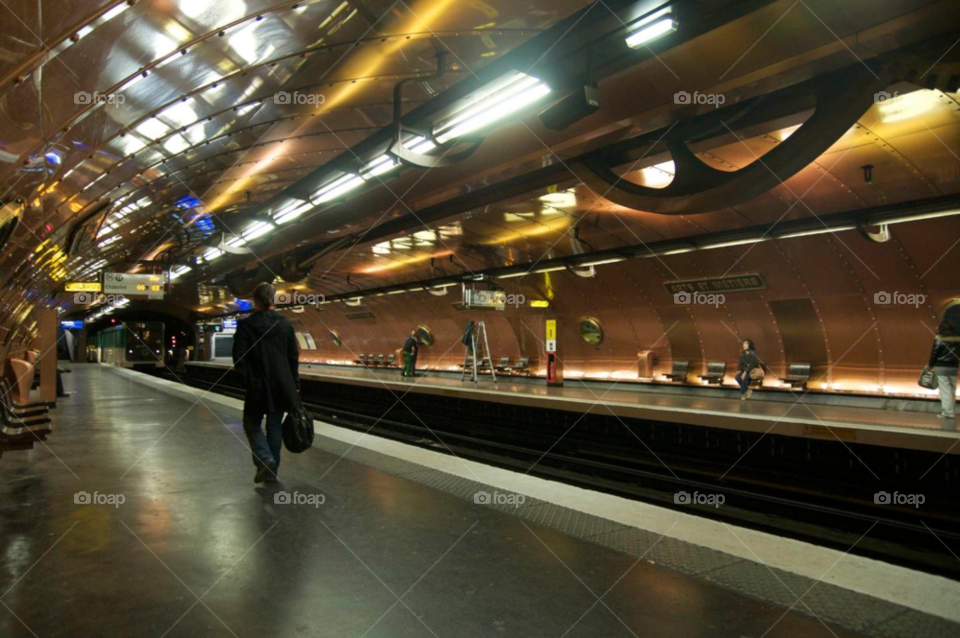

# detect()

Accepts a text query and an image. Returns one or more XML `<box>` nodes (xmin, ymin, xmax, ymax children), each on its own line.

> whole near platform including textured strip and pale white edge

<box><xmin>0</xmin><ymin>365</ymin><xmax>960</xmax><ymax>638</ymax></box>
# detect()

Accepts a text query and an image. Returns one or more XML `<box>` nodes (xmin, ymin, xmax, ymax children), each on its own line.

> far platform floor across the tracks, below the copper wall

<box><xmin>189</xmin><ymin>363</ymin><xmax>960</xmax><ymax>454</ymax></box>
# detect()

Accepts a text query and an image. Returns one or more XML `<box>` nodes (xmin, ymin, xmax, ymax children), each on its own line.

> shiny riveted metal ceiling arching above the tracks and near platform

<box><xmin>0</xmin><ymin>0</ymin><xmax>960</xmax><ymax>330</ymax></box>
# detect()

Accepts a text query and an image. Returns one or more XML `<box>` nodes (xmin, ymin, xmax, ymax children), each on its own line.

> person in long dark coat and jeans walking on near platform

<box><xmin>233</xmin><ymin>282</ymin><xmax>300</xmax><ymax>483</ymax></box>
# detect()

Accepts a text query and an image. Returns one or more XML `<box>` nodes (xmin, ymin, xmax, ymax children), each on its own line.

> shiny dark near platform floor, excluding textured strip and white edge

<box><xmin>0</xmin><ymin>365</ymin><xmax>855</xmax><ymax>638</ymax></box>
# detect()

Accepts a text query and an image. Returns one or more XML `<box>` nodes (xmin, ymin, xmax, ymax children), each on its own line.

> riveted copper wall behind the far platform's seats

<box><xmin>290</xmin><ymin>217</ymin><xmax>960</xmax><ymax>393</ymax></box>
